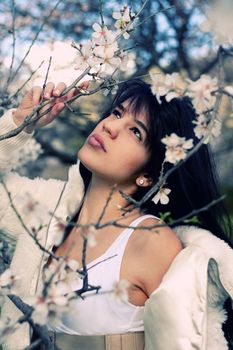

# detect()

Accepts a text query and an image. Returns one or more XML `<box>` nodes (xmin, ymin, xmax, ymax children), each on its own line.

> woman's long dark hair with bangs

<box><xmin>80</xmin><ymin>79</ymin><xmax>233</xmax><ymax>344</ymax></box>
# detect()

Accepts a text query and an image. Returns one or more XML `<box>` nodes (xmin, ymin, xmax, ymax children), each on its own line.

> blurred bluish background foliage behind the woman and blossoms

<box><xmin>0</xmin><ymin>0</ymin><xmax>233</xmax><ymax>227</ymax></box>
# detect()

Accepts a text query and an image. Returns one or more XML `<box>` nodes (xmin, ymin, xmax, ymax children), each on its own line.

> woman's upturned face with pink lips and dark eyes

<box><xmin>78</xmin><ymin>100</ymin><xmax>150</xmax><ymax>184</ymax></box>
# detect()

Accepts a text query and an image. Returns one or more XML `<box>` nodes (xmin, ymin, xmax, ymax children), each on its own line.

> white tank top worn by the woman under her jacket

<box><xmin>48</xmin><ymin>214</ymin><xmax>158</xmax><ymax>335</ymax></box>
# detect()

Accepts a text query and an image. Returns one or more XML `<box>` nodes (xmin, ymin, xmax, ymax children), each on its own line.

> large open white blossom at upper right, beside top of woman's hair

<box><xmin>187</xmin><ymin>75</ymin><xmax>217</xmax><ymax>113</ymax></box>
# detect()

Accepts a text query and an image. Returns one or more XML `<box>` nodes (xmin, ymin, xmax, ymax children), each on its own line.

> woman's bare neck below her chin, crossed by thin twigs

<box><xmin>78</xmin><ymin>176</ymin><xmax>140</xmax><ymax>224</ymax></box>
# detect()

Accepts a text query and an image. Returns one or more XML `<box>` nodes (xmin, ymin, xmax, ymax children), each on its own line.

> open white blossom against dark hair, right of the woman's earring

<box><xmin>161</xmin><ymin>133</ymin><xmax>193</xmax><ymax>164</ymax></box>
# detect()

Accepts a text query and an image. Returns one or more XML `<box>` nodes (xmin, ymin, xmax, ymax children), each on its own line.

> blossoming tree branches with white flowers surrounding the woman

<box><xmin>0</xmin><ymin>1</ymin><xmax>233</xmax><ymax>349</ymax></box>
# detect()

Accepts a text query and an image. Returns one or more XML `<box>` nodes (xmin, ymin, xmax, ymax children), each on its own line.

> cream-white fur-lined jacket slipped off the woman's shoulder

<box><xmin>0</xmin><ymin>111</ymin><xmax>233</xmax><ymax>350</ymax></box>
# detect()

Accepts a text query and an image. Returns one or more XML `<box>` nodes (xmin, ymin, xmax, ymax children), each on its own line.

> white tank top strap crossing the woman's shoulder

<box><xmin>108</xmin><ymin>214</ymin><xmax>161</xmax><ymax>255</ymax></box>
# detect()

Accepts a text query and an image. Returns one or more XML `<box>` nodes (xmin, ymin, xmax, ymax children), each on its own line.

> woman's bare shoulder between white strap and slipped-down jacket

<box><xmin>133</xmin><ymin>218</ymin><xmax>183</xmax><ymax>296</ymax></box>
